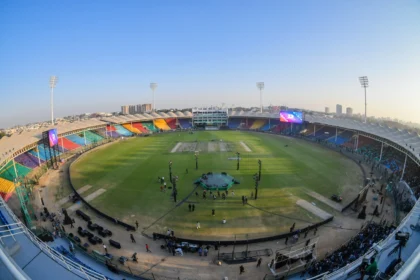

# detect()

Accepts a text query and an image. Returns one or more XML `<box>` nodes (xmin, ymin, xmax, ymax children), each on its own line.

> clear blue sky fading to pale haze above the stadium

<box><xmin>0</xmin><ymin>0</ymin><xmax>420</xmax><ymax>128</ymax></box>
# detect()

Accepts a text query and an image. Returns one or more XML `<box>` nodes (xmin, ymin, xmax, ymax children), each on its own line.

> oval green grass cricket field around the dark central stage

<box><xmin>70</xmin><ymin>131</ymin><xmax>362</xmax><ymax>239</ymax></box>
